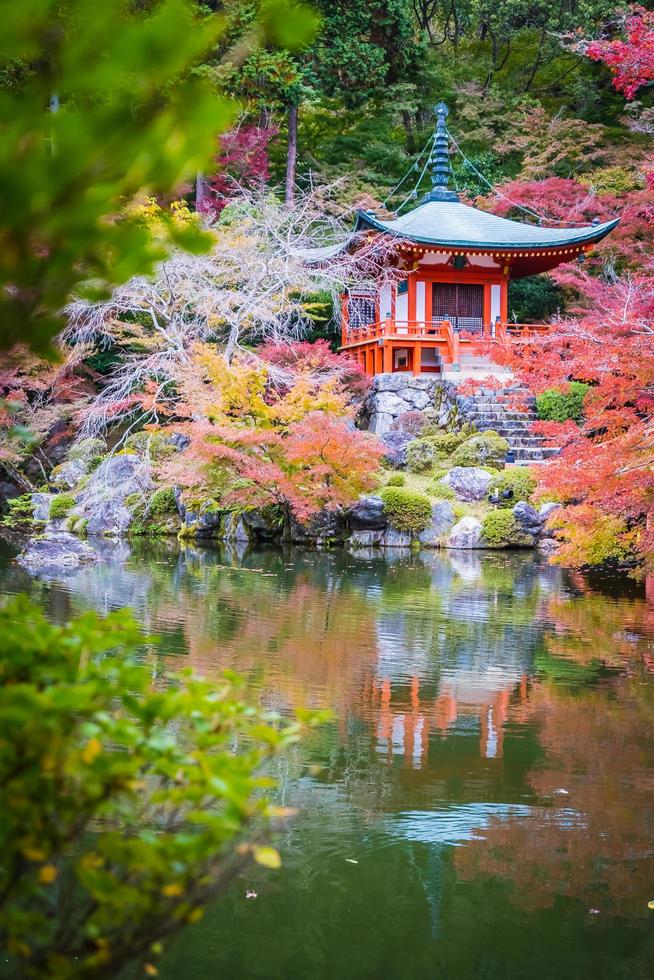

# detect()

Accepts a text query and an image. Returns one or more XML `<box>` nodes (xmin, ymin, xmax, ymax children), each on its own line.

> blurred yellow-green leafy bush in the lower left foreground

<box><xmin>0</xmin><ymin>597</ymin><xmax>322</xmax><ymax>980</ymax></box>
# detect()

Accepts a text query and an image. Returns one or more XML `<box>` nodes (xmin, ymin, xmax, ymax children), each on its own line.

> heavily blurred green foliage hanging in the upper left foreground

<box><xmin>0</xmin><ymin>0</ymin><xmax>316</xmax><ymax>350</ymax></box>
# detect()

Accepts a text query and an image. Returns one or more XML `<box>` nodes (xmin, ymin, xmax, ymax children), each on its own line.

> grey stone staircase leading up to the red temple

<box><xmin>457</xmin><ymin>385</ymin><xmax>559</xmax><ymax>466</ymax></box>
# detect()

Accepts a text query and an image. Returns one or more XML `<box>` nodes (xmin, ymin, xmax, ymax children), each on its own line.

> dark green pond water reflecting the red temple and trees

<box><xmin>0</xmin><ymin>544</ymin><xmax>654</xmax><ymax>980</ymax></box>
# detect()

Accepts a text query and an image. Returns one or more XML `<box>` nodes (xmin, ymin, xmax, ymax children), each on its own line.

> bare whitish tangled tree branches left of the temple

<box><xmin>61</xmin><ymin>188</ymin><xmax>389</xmax><ymax>438</ymax></box>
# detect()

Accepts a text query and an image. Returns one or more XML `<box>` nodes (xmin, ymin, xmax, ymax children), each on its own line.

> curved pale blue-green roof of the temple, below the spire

<box><xmin>356</xmin><ymin>201</ymin><xmax>620</xmax><ymax>251</ymax></box>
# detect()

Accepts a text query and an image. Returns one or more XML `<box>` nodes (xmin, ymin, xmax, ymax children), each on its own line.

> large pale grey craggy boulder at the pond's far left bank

<box><xmin>70</xmin><ymin>453</ymin><xmax>153</xmax><ymax>537</ymax></box>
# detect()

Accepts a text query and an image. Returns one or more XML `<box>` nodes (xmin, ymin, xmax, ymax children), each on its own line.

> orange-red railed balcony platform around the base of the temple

<box><xmin>340</xmin><ymin>318</ymin><xmax>548</xmax><ymax>375</ymax></box>
